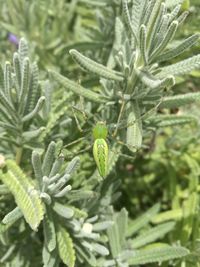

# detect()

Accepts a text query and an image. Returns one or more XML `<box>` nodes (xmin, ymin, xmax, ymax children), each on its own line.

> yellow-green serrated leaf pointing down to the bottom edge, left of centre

<box><xmin>57</xmin><ymin>225</ymin><xmax>76</xmax><ymax>267</ymax></box>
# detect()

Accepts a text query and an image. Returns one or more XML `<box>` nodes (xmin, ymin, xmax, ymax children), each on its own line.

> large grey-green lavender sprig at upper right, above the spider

<box><xmin>51</xmin><ymin>1</ymin><xmax>199</xmax><ymax>155</ymax></box>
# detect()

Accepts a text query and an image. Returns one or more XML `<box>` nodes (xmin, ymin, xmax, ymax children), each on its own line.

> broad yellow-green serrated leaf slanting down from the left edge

<box><xmin>0</xmin><ymin>160</ymin><xmax>44</xmax><ymax>231</ymax></box>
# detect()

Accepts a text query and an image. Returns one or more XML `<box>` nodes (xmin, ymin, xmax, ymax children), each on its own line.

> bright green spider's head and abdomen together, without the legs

<box><xmin>93</xmin><ymin>121</ymin><xmax>108</xmax><ymax>178</ymax></box>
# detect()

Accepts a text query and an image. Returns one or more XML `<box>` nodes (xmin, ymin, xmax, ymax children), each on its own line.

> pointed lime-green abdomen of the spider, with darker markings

<box><xmin>93</xmin><ymin>138</ymin><xmax>108</xmax><ymax>178</ymax></box>
